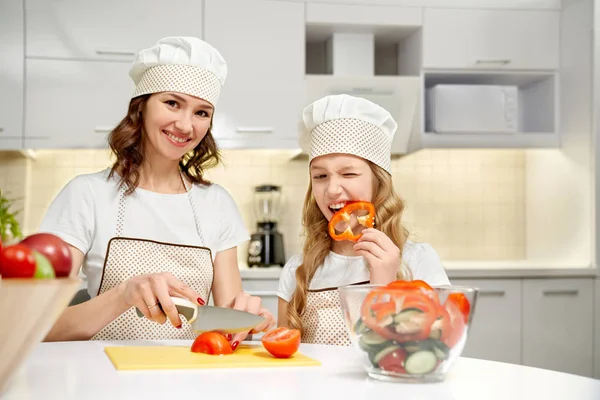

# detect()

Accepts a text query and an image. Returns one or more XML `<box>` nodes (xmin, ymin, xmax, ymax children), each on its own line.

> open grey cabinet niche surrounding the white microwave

<box><xmin>420</xmin><ymin>70</ymin><xmax>560</xmax><ymax>148</ymax></box>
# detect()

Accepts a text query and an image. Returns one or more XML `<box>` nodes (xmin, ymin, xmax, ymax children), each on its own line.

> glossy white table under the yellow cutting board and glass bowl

<box><xmin>0</xmin><ymin>341</ymin><xmax>600</xmax><ymax>400</ymax></box>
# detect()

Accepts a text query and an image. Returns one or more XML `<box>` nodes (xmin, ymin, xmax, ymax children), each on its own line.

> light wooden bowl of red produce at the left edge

<box><xmin>0</xmin><ymin>233</ymin><xmax>81</xmax><ymax>394</ymax></box>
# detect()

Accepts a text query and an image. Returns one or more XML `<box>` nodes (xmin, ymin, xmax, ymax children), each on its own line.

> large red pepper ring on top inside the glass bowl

<box><xmin>361</xmin><ymin>288</ymin><xmax>439</xmax><ymax>343</ymax></box>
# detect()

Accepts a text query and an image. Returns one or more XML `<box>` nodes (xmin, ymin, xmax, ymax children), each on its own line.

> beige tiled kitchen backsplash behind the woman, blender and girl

<box><xmin>0</xmin><ymin>149</ymin><xmax>526</xmax><ymax>263</ymax></box>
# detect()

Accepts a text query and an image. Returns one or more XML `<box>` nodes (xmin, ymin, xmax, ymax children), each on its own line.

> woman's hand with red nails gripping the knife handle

<box><xmin>120</xmin><ymin>272</ymin><xmax>204</xmax><ymax>328</ymax></box>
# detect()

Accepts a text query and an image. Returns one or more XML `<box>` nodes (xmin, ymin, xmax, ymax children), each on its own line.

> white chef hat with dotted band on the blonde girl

<box><xmin>302</xmin><ymin>94</ymin><xmax>398</xmax><ymax>174</ymax></box>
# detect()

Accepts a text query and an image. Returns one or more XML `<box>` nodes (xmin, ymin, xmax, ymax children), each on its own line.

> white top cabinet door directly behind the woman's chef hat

<box><xmin>25</xmin><ymin>0</ymin><xmax>202</xmax><ymax>60</ymax></box>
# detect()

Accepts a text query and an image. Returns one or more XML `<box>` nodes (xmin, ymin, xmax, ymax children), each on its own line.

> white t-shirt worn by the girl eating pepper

<box><xmin>277</xmin><ymin>241</ymin><xmax>450</xmax><ymax>302</ymax></box>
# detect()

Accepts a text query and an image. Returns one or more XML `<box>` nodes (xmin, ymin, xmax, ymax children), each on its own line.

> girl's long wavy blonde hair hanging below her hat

<box><xmin>287</xmin><ymin>161</ymin><xmax>411</xmax><ymax>333</ymax></box>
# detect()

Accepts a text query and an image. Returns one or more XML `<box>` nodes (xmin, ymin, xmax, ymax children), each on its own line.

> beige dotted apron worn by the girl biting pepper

<box><xmin>302</xmin><ymin>281</ymin><xmax>369</xmax><ymax>346</ymax></box>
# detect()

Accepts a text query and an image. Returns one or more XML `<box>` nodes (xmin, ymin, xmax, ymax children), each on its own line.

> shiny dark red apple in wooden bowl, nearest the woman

<box><xmin>21</xmin><ymin>233</ymin><xmax>72</xmax><ymax>278</ymax></box>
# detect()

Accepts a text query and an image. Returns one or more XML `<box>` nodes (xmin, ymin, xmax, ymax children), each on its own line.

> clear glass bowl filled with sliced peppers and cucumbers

<box><xmin>338</xmin><ymin>280</ymin><xmax>478</xmax><ymax>383</ymax></box>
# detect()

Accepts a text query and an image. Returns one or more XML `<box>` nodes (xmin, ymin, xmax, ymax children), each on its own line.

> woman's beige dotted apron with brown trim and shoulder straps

<box><xmin>92</xmin><ymin>178</ymin><xmax>213</xmax><ymax>340</ymax></box>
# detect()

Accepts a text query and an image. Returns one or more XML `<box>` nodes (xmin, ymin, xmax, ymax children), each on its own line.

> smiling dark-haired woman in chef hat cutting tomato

<box><xmin>40</xmin><ymin>37</ymin><xmax>273</xmax><ymax>348</ymax></box>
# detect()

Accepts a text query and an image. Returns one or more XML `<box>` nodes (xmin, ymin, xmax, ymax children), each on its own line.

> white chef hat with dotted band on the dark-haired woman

<box><xmin>129</xmin><ymin>37</ymin><xmax>227</xmax><ymax>106</ymax></box>
